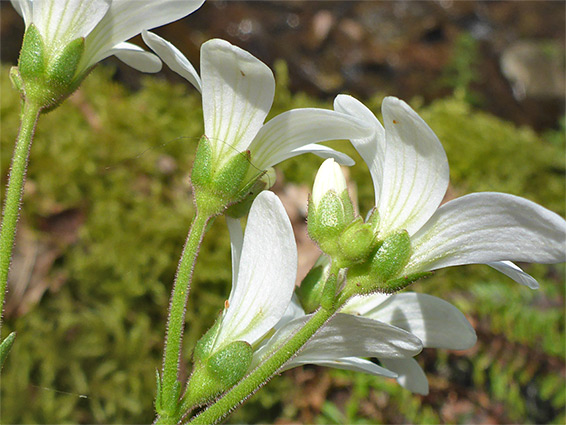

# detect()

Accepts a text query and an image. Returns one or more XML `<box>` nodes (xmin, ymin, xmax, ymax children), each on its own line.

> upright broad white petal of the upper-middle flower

<box><xmin>201</xmin><ymin>39</ymin><xmax>275</xmax><ymax>161</ymax></box>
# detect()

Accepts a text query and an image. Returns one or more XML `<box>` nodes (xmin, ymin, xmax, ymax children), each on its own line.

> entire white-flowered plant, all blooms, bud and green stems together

<box><xmin>7</xmin><ymin>0</ymin><xmax>566</xmax><ymax>423</ymax></box>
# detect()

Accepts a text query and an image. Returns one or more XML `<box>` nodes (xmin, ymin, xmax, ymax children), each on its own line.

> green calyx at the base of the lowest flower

<box><xmin>184</xmin><ymin>341</ymin><xmax>253</xmax><ymax>407</ymax></box>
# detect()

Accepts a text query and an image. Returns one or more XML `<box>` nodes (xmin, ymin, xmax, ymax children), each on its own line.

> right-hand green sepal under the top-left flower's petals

<box><xmin>47</xmin><ymin>37</ymin><xmax>85</xmax><ymax>88</ymax></box>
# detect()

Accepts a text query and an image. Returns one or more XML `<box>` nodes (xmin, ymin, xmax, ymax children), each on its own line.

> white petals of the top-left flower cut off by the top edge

<box><xmin>11</xmin><ymin>0</ymin><xmax>204</xmax><ymax>75</ymax></box>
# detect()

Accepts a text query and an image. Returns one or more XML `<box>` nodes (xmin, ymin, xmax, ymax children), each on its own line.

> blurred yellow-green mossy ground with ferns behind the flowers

<box><xmin>0</xmin><ymin>64</ymin><xmax>566</xmax><ymax>424</ymax></box>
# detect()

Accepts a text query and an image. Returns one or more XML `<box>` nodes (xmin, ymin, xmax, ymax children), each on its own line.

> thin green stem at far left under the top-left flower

<box><xmin>0</xmin><ymin>101</ymin><xmax>41</xmax><ymax>326</ymax></box>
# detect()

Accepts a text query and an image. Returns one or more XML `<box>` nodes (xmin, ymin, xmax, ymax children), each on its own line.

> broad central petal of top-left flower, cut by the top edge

<box><xmin>32</xmin><ymin>0</ymin><xmax>111</xmax><ymax>49</ymax></box>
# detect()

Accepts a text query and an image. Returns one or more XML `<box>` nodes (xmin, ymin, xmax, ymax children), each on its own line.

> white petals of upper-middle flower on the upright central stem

<box><xmin>142</xmin><ymin>31</ymin><xmax>373</xmax><ymax>178</ymax></box>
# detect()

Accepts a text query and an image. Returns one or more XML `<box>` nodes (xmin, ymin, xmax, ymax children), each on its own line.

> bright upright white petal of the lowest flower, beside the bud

<box><xmin>215</xmin><ymin>191</ymin><xmax>297</xmax><ymax>347</ymax></box>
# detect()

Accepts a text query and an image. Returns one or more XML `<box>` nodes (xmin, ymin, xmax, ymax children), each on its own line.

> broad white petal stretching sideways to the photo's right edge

<box><xmin>407</xmin><ymin>192</ymin><xmax>566</xmax><ymax>273</ymax></box>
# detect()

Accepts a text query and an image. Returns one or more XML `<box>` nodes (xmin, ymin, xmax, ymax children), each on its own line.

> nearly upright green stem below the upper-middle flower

<box><xmin>161</xmin><ymin>209</ymin><xmax>212</xmax><ymax>413</ymax></box>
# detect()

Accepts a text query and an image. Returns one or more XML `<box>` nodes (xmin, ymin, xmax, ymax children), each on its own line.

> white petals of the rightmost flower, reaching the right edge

<box><xmin>334</xmin><ymin>95</ymin><xmax>566</xmax><ymax>288</ymax></box>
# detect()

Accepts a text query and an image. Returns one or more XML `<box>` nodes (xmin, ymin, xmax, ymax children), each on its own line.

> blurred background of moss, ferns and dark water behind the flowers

<box><xmin>0</xmin><ymin>0</ymin><xmax>566</xmax><ymax>424</ymax></box>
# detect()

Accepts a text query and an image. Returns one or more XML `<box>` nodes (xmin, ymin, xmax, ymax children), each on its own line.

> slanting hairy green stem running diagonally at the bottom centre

<box><xmin>188</xmin><ymin>265</ymin><xmax>347</xmax><ymax>425</ymax></box>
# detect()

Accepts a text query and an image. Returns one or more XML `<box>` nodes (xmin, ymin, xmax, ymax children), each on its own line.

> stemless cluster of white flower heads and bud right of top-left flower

<box><xmin>143</xmin><ymin>26</ymin><xmax>566</xmax><ymax>405</ymax></box>
